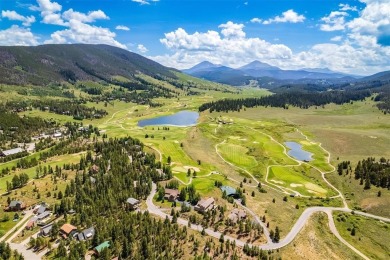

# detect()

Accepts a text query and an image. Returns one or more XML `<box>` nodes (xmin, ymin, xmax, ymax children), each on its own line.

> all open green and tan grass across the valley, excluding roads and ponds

<box><xmin>0</xmin><ymin>85</ymin><xmax>390</xmax><ymax>259</ymax></box>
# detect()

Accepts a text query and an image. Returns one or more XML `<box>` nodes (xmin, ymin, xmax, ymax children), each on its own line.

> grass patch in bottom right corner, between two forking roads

<box><xmin>333</xmin><ymin>212</ymin><xmax>390</xmax><ymax>259</ymax></box>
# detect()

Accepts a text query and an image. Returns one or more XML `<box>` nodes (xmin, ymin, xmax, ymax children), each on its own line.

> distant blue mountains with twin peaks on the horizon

<box><xmin>182</xmin><ymin>61</ymin><xmax>359</xmax><ymax>85</ymax></box>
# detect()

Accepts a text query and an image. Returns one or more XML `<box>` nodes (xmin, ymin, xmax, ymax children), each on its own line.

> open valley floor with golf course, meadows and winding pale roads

<box><xmin>0</xmin><ymin>92</ymin><xmax>390</xmax><ymax>259</ymax></box>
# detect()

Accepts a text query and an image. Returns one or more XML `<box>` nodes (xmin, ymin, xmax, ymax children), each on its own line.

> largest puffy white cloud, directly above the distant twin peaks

<box><xmin>155</xmin><ymin>21</ymin><xmax>292</xmax><ymax>68</ymax></box>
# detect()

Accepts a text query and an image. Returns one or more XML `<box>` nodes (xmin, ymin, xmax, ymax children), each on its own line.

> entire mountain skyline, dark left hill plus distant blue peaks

<box><xmin>0</xmin><ymin>44</ymin><xmax>390</xmax><ymax>89</ymax></box>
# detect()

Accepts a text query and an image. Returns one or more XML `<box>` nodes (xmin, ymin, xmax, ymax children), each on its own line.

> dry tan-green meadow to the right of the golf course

<box><xmin>209</xmin><ymin>99</ymin><xmax>390</xmax><ymax>214</ymax></box>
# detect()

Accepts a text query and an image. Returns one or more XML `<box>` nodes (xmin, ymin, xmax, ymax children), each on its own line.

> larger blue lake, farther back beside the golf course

<box><xmin>138</xmin><ymin>110</ymin><xmax>199</xmax><ymax>127</ymax></box>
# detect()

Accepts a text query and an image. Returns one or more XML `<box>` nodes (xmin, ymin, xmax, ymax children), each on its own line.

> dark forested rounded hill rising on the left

<box><xmin>0</xmin><ymin>44</ymin><xmax>176</xmax><ymax>85</ymax></box>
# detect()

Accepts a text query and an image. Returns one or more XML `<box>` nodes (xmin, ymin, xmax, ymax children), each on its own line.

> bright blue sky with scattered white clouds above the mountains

<box><xmin>0</xmin><ymin>0</ymin><xmax>390</xmax><ymax>75</ymax></box>
